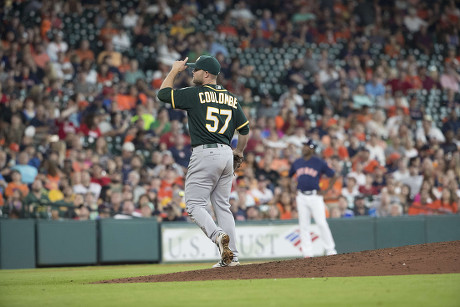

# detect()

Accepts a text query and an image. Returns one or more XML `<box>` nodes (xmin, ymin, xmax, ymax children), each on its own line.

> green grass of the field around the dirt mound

<box><xmin>0</xmin><ymin>263</ymin><xmax>460</xmax><ymax>307</ymax></box>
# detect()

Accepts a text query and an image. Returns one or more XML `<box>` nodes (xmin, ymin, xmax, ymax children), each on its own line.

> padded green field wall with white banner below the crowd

<box><xmin>0</xmin><ymin>215</ymin><xmax>460</xmax><ymax>269</ymax></box>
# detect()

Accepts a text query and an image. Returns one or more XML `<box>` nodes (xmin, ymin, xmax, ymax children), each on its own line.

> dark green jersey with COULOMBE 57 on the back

<box><xmin>158</xmin><ymin>84</ymin><xmax>249</xmax><ymax>146</ymax></box>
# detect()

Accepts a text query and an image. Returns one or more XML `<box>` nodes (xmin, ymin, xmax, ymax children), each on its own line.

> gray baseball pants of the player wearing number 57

<box><xmin>185</xmin><ymin>144</ymin><xmax>238</xmax><ymax>260</ymax></box>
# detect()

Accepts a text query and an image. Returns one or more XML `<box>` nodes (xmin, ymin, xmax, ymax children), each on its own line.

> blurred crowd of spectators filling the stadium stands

<box><xmin>0</xmin><ymin>0</ymin><xmax>460</xmax><ymax>222</ymax></box>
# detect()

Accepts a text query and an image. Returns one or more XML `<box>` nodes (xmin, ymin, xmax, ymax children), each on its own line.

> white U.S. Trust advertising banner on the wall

<box><xmin>162</xmin><ymin>224</ymin><xmax>324</xmax><ymax>262</ymax></box>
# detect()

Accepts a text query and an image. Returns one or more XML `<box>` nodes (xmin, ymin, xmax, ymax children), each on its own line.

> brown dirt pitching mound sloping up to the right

<box><xmin>99</xmin><ymin>241</ymin><xmax>460</xmax><ymax>283</ymax></box>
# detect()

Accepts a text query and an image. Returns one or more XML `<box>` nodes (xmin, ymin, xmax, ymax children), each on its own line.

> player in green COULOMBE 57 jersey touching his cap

<box><xmin>158</xmin><ymin>55</ymin><xmax>249</xmax><ymax>267</ymax></box>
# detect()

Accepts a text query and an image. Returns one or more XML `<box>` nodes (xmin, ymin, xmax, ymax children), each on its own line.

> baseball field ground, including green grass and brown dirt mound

<box><xmin>0</xmin><ymin>241</ymin><xmax>460</xmax><ymax>307</ymax></box>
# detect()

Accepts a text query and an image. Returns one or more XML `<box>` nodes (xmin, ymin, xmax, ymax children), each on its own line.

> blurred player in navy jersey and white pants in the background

<box><xmin>289</xmin><ymin>140</ymin><xmax>337</xmax><ymax>258</ymax></box>
